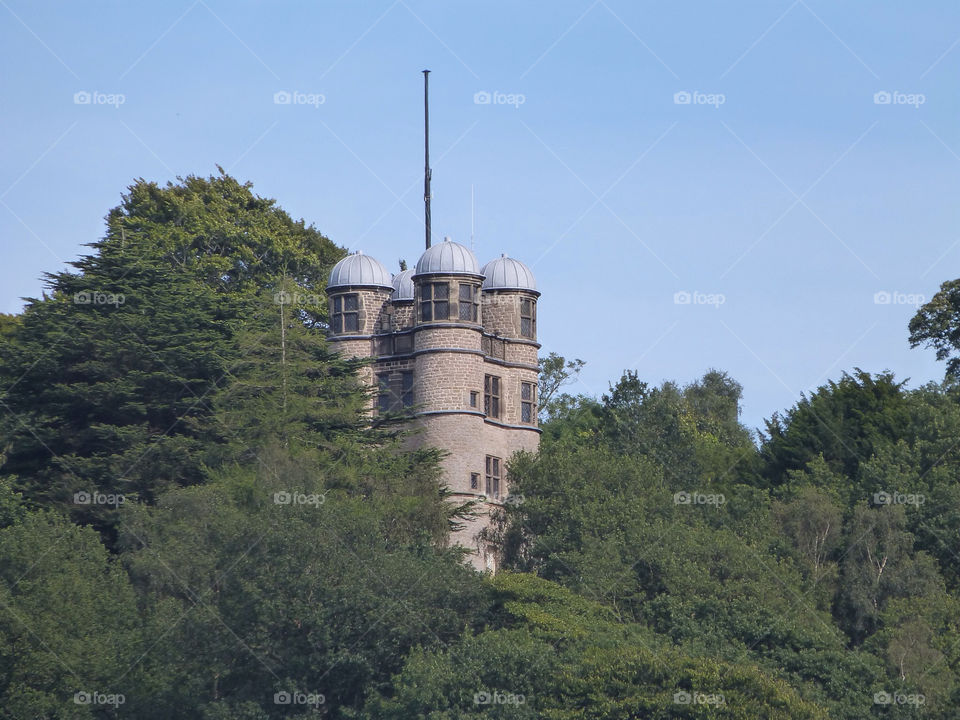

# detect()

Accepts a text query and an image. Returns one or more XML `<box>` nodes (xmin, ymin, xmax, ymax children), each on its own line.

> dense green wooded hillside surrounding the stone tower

<box><xmin>0</xmin><ymin>171</ymin><xmax>960</xmax><ymax>720</ymax></box>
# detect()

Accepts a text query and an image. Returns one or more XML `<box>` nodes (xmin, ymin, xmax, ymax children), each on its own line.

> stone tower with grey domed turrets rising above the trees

<box><xmin>327</xmin><ymin>239</ymin><xmax>540</xmax><ymax>570</ymax></box>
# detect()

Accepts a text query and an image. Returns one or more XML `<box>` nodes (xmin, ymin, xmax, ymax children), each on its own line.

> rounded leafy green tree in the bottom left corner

<box><xmin>0</xmin><ymin>511</ymin><xmax>144</xmax><ymax>718</ymax></box>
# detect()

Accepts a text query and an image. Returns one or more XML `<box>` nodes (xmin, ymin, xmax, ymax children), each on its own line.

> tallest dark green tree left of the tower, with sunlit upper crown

<box><xmin>0</xmin><ymin>170</ymin><xmax>343</xmax><ymax>530</ymax></box>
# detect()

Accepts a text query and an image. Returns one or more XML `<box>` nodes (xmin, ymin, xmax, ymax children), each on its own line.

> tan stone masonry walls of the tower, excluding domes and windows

<box><xmin>331</xmin><ymin>276</ymin><xmax>540</xmax><ymax>570</ymax></box>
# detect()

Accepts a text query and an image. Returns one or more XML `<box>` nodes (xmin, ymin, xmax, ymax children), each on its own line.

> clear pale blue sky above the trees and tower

<box><xmin>0</xmin><ymin>0</ymin><xmax>960</xmax><ymax>434</ymax></box>
